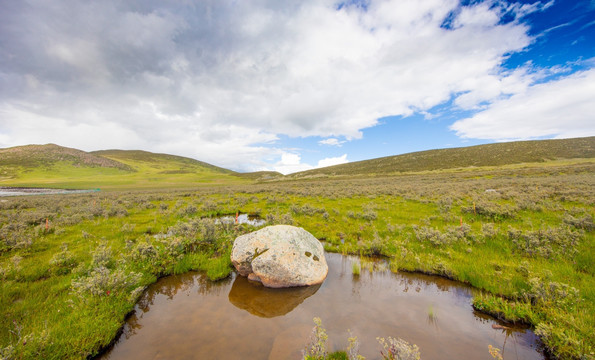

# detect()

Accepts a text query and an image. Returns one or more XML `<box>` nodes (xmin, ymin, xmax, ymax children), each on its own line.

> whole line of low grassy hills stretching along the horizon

<box><xmin>0</xmin><ymin>137</ymin><xmax>595</xmax><ymax>189</ymax></box>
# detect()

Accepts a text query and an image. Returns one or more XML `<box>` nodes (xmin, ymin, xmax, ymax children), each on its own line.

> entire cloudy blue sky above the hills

<box><xmin>0</xmin><ymin>0</ymin><xmax>595</xmax><ymax>173</ymax></box>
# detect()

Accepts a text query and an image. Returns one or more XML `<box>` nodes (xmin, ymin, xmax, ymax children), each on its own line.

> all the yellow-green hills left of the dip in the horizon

<box><xmin>0</xmin><ymin>144</ymin><xmax>248</xmax><ymax>189</ymax></box>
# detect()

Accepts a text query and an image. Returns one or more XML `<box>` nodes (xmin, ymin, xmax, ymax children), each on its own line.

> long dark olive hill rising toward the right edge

<box><xmin>288</xmin><ymin>136</ymin><xmax>595</xmax><ymax>178</ymax></box>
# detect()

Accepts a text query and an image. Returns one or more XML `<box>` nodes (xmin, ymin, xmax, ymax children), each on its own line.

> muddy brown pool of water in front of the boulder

<box><xmin>103</xmin><ymin>254</ymin><xmax>544</xmax><ymax>360</ymax></box>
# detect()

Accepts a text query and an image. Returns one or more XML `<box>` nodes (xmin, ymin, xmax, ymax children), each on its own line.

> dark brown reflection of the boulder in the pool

<box><xmin>229</xmin><ymin>276</ymin><xmax>320</xmax><ymax>318</ymax></box>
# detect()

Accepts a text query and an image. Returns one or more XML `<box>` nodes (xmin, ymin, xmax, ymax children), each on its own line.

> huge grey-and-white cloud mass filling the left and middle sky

<box><xmin>0</xmin><ymin>0</ymin><xmax>572</xmax><ymax>171</ymax></box>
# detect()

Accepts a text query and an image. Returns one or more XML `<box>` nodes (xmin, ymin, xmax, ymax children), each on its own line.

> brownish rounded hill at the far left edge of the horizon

<box><xmin>0</xmin><ymin>144</ymin><xmax>132</xmax><ymax>171</ymax></box>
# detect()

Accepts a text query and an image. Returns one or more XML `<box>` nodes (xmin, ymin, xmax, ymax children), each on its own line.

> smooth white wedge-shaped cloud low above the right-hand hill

<box><xmin>450</xmin><ymin>69</ymin><xmax>595</xmax><ymax>140</ymax></box>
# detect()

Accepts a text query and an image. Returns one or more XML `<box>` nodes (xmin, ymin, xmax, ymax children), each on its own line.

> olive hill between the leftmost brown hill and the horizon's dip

<box><xmin>91</xmin><ymin>150</ymin><xmax>236</xmax><ymax>175</ymax></box>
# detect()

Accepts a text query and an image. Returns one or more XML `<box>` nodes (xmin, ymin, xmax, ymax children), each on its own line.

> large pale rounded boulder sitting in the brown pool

<box><xmin>231</xmin><ymin>225</ymin><xmax>328</xmax><ymax>288</ymax></box>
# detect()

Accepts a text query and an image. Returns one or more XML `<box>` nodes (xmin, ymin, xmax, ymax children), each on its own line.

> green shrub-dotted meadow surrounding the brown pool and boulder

<box><xmin>0</xmin><ymin>139</ymin><xmax>595</xmax><ymax>359</ymax></box>
